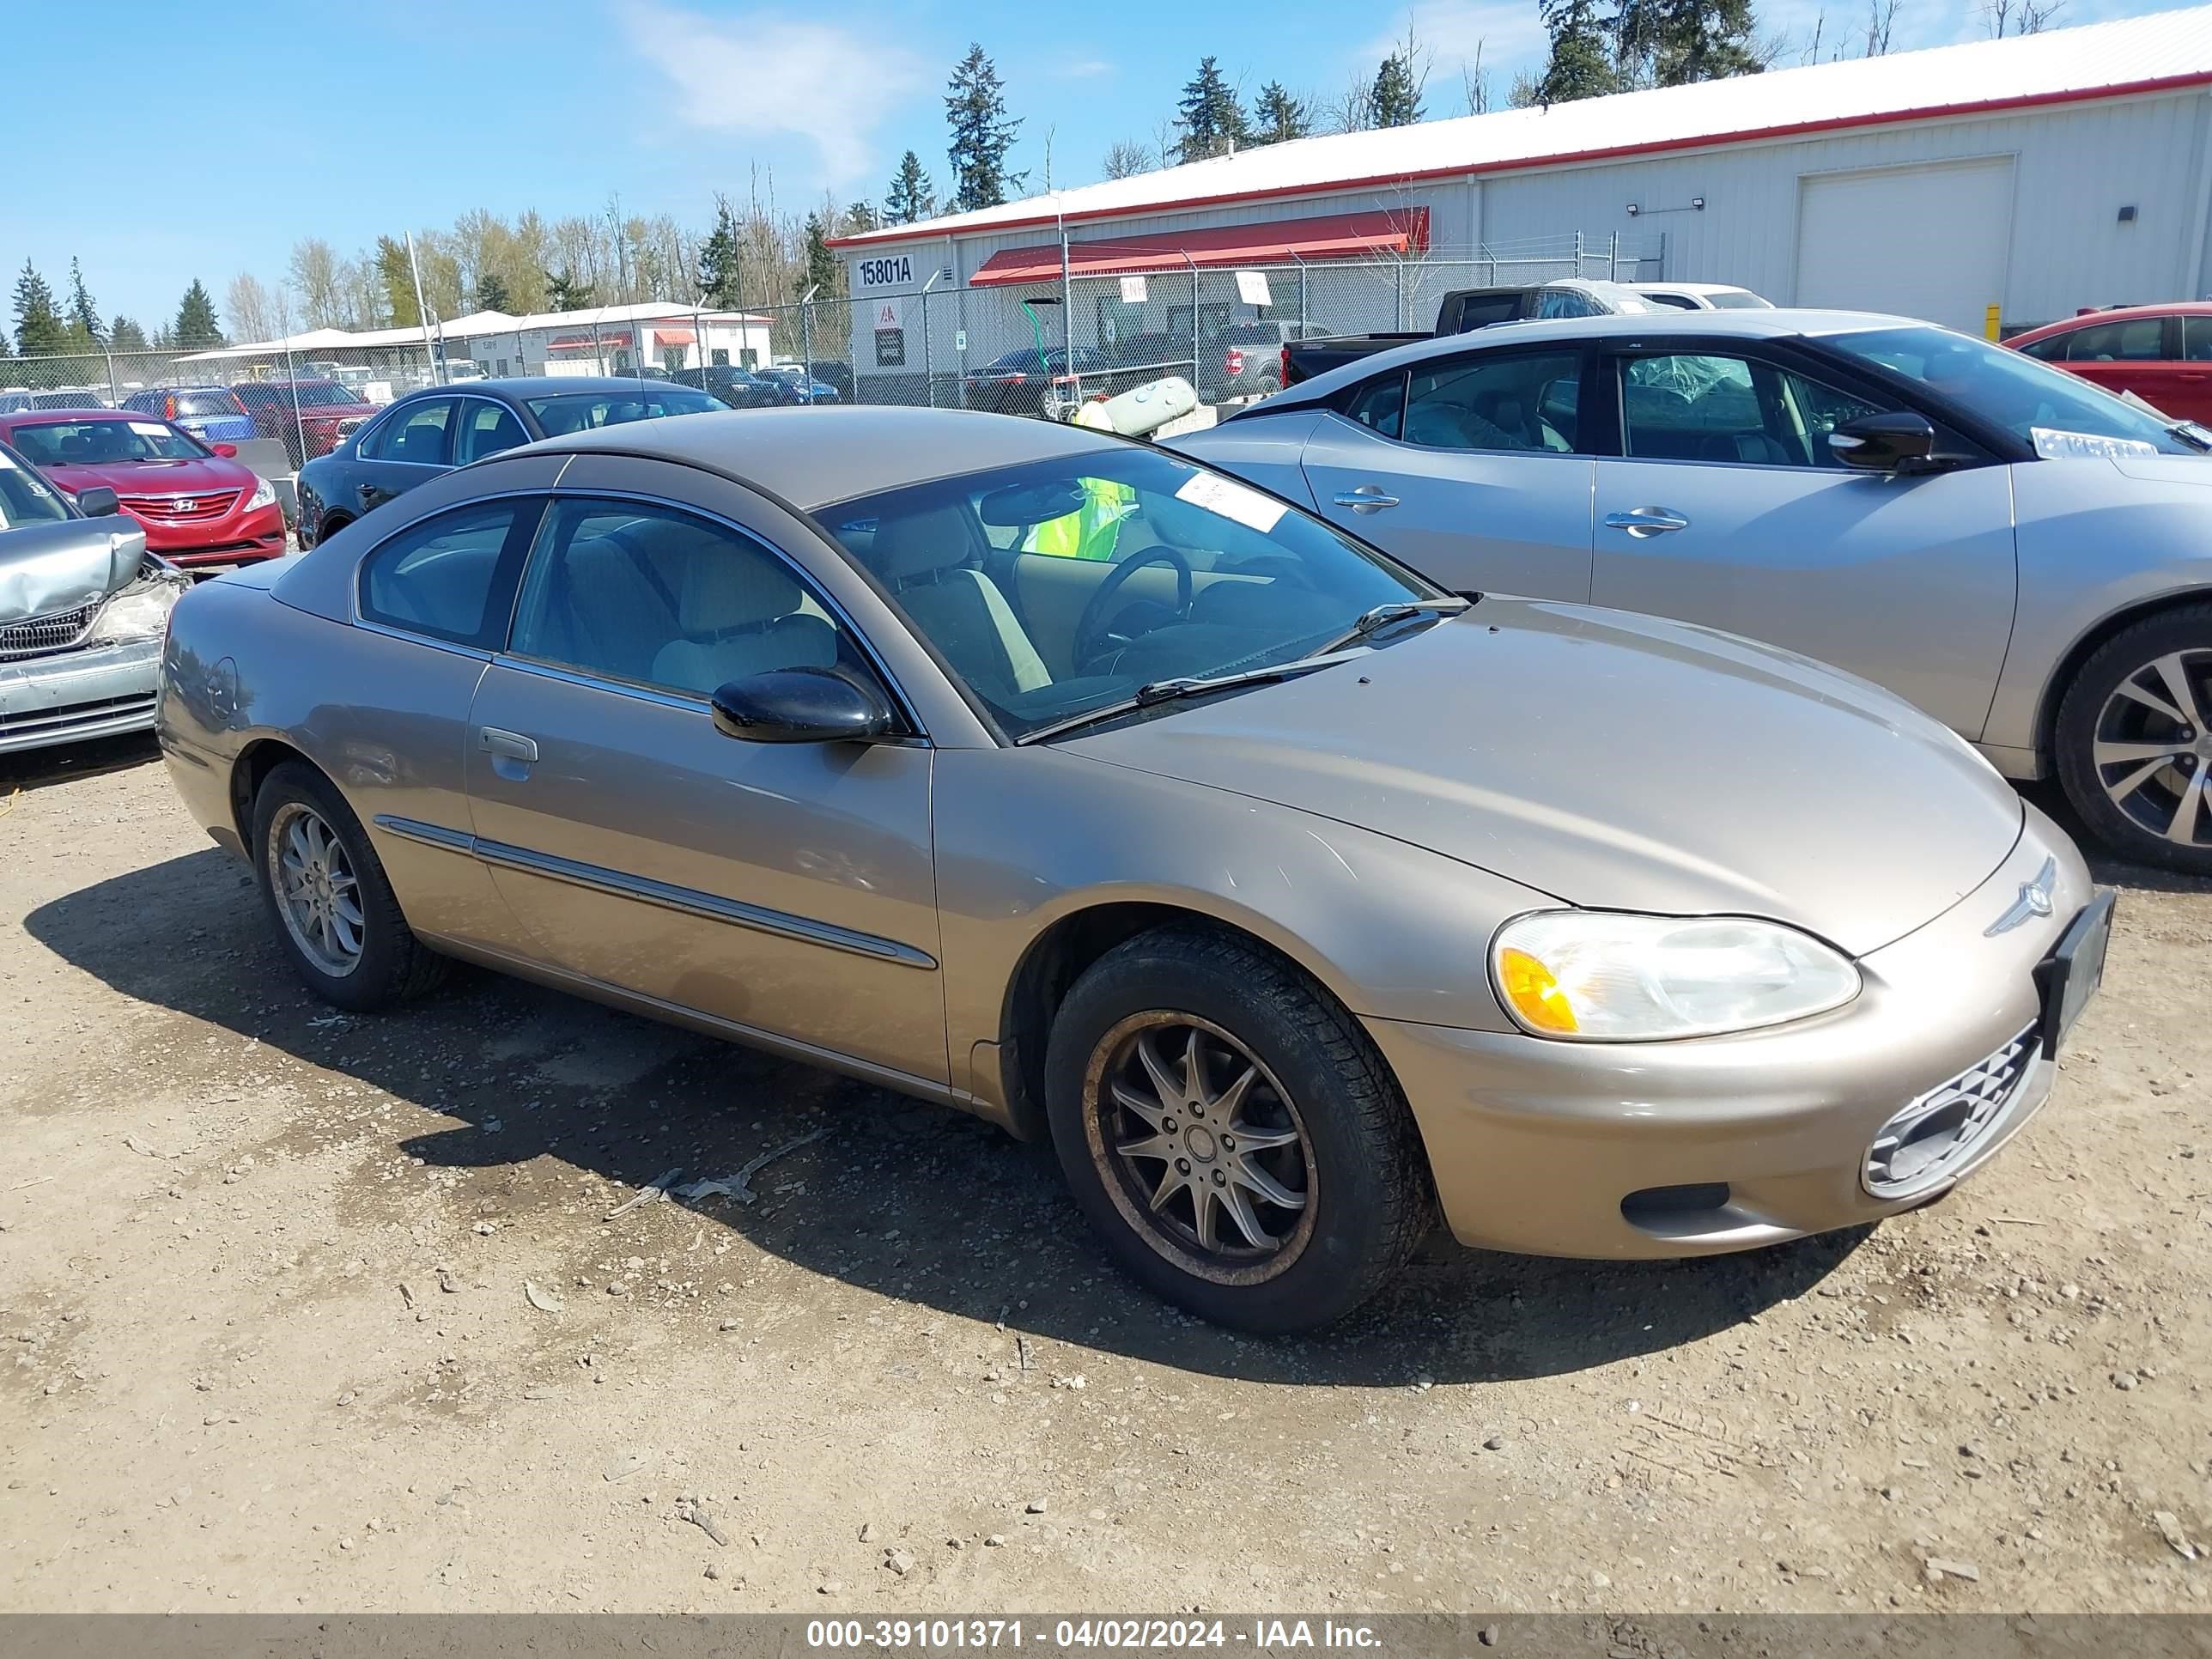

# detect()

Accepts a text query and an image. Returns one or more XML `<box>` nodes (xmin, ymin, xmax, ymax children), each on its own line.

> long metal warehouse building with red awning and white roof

<box><xmin>817</xmin><ymin>7</ymin><xmax>2212</xmax><ymax>403</ymax></box>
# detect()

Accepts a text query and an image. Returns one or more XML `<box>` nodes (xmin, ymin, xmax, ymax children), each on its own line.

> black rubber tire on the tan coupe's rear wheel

<box><xmin>252</xmin><ymin>761</ymin><xmax>449</xmax><ymax>1013</ymax></box>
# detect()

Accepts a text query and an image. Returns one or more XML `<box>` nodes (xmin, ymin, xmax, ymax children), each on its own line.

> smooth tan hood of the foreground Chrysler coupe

<box><xmin>1064</xmin><ymin>599</ymin><xmax>2021</xmax><ymax>956</ymax></box>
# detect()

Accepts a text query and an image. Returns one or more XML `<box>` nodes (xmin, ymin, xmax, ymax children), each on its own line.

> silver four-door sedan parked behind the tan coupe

<box><xmin>1170</xmin><ymin>310</ymin><xmax>2212</xmax><ymax>874</ymax></box>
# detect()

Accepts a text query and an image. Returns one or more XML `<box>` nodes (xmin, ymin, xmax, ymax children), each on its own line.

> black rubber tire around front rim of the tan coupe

<box><xmin>1044</xmin><ymin>927</ymin><xmax>1436</xmax><ymax>1336</ymax></box>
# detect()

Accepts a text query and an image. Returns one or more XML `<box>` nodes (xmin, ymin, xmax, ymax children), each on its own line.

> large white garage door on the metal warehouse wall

<box><xmin>1796</xmin><ymin>155</ymin><xmax>2013</xmax><ymax>334</ymax></box>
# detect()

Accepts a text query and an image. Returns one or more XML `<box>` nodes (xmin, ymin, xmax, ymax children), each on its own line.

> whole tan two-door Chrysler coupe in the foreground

<box><xmin>159</xmin><ymin>410</ymin><xmax>2111</xmax><ymax>1332</ymax></box>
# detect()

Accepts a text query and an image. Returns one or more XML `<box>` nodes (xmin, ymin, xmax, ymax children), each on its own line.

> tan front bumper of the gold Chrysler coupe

<box><xmin>1364</xmin><ymin>807</ymin><xmax>2094</xmax><ymax>1256</ymax></box>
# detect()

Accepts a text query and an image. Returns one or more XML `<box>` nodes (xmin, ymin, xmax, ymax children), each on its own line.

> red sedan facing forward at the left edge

<box><xmin>0</xmin><ymin>410</ymin><xmax>283</xmax><ymax>568</ymax></box>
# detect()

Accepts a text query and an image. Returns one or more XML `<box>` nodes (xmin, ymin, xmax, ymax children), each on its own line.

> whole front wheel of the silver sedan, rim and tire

<box><xmin>2057</xmin><ymin>606</ymin><xmax>2212</xmax><ymax>876</ymax></box>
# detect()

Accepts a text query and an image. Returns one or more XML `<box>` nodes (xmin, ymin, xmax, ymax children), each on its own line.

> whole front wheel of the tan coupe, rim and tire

<box><xmin>1046</xmin><ymin>927</ymin><xmax>1436</xmax><ymax>1334</ymax></box>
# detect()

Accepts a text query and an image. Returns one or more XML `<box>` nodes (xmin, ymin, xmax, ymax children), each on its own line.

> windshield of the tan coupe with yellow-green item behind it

<box><xmin>817</xmin><ymin>445</ymin><xmax>1444</xmax><ymax>738</ymax></box>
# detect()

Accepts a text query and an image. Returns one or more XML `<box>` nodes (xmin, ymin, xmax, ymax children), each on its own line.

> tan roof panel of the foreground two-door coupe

<box><xmin>507</xmin><ymin>406</ymin><xmax>1128</xmax><ymax>511</ymax></box>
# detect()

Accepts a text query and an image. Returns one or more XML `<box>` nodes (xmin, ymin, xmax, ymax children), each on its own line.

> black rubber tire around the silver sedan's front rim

<box><xmin>2053</xmin><ymin>604</ymin><xmax>2212</xmax><ymax>876</ymax></box>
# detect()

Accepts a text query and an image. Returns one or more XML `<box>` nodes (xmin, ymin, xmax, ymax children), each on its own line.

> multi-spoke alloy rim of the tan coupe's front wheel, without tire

<box><xmin>1084</xmin><ymin>1011</ymin><xmax>1314</xmax><ymax>1285</ymax></box>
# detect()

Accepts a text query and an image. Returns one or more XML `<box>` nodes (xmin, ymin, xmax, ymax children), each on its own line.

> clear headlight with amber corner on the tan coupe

<box><xmin>1491</xmin><ymin>909</ymin><xmax>1858</xmax><ymax>1042</ymax></box>
